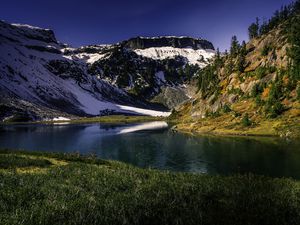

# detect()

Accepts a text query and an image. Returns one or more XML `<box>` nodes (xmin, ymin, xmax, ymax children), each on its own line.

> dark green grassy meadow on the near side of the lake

<box><xmin>0</xmin><ymin>150</ymin><xmax>300</xmax><ymax>225</ymax></box>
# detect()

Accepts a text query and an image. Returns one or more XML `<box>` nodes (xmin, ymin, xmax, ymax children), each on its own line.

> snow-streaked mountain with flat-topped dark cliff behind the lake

<box><xmin>0</xmin><ymin>21</ymin><xmax>215</xmax><ymax>120</ymax></box>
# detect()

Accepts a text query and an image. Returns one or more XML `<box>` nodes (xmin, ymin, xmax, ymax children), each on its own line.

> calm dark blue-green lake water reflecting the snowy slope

<box><xmin>0</xmin><ymin>122</ymin><xmax>300</xmax><ymax>179</ymax></box>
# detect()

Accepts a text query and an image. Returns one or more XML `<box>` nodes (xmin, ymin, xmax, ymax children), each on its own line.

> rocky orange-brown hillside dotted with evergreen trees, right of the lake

<box><xmin>171</xmin><ymin>2</ymin><xmax>300</xmax><ymax>137</ymax></box>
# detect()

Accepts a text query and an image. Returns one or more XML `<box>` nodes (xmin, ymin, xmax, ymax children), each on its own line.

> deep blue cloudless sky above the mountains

<box><xmin>0</xmin><ymin>0</ymin><xmax>292</xmax><ymax>50</ymax></box>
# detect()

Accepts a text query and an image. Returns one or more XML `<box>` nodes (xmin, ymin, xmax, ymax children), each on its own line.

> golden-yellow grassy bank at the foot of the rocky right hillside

<box><xmin>169</xmin><ymin>100</ymin><xmax>300</xmax><ymax>138</ymax></box>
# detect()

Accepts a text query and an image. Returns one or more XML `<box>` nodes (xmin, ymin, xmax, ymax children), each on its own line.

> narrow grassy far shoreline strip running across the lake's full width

<box><xmin>0</xmin><ymin>115</ymin><xmax>300</xmax><ymax>139</ymax></box>
